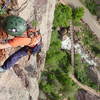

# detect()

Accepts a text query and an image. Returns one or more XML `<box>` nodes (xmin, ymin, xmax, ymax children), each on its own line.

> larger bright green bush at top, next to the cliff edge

<box><xmin>54</xmin><ymin>4</ymin><xmax>72</xmax><ymax>27</ymax></box>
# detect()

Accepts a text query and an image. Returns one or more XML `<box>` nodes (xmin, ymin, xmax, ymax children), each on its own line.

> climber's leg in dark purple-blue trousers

<box><xmin>1</xmin><ymin>45</ymin><xmax>41</xmax><ymax>70</ymax></box>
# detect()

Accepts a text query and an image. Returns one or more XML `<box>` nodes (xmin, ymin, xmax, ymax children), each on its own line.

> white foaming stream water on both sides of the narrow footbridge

<box><xmin>62</xmin><ymin>36</ymin><xmax>97</xmax><ymax>66</ymax></box>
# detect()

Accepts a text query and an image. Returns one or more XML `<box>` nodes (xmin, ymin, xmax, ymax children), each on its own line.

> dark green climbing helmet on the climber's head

<box><xmin>3</xmin><ymin>16</ymin><xmax>27</xmax><ymax>36</ymax></box>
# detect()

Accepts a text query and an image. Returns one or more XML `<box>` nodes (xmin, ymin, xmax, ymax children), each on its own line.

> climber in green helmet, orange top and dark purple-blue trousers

<box><xmin>0</xmin><ymin>16</ymin><xmax>41</xmax><ymax>72</ymax></box>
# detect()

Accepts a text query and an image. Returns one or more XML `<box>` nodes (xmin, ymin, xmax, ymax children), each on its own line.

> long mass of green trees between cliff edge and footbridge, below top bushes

<box><xmin>40</xmin><ymin>30</ymin><xmax>78</xmax><ymax>100</ymax></box>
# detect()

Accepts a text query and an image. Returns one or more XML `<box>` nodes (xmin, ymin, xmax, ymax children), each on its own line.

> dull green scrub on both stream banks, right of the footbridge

<box><xmin>75</xmin><ymin>13</ymin><xmax>100</xmax><ymax>90</ymax></box>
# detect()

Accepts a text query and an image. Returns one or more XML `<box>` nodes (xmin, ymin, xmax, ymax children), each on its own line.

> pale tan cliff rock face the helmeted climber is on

<box><xmin>0</xmin><ymin>0</ymin><xmax>56</xmax><ymax>100</ymax></box>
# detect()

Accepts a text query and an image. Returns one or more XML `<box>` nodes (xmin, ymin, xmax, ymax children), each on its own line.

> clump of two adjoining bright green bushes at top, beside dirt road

<box><xmin>53</xmin><ymin>4</ymin><xmax>84</xmax><ymax>27</ymax></box>
